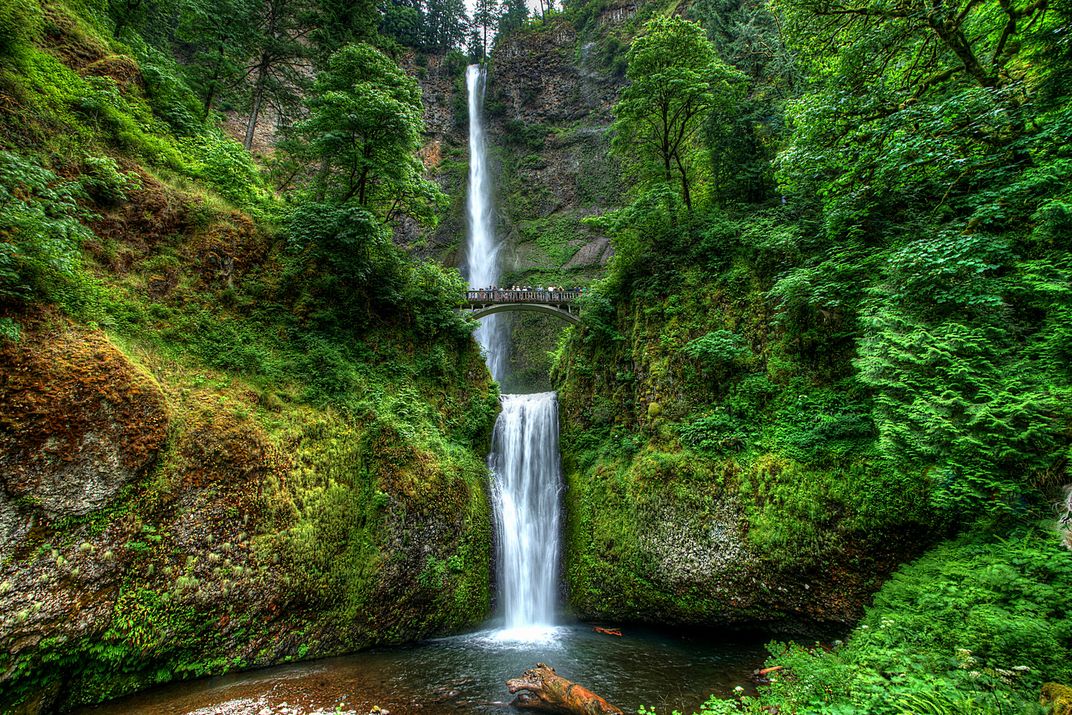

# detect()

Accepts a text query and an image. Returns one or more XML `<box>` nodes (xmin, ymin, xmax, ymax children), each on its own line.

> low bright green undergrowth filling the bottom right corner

<box><xmin>747</xmin><ymin>530</ymin><xmax>1072</xmax><ymax>715</ymax></box>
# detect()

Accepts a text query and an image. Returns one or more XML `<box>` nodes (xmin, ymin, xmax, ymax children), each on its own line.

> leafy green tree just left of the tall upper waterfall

<box><xmin>296</xmin><ymin>44</ymin><xmax>441</xmax><ymax>219</ymax></box>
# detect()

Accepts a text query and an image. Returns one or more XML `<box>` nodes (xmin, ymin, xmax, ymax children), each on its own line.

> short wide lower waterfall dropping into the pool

<box><xmin>488</xmin><ymin>392</ymin><xmax>562</xmax><ymax>636</ymax></box>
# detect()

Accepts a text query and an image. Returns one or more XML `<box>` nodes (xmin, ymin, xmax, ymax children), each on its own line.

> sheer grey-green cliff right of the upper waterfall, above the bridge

<box><xmin>489</xmin><ymin>16</ymin><xmax>623</xmax><ymax>282</ymax></box>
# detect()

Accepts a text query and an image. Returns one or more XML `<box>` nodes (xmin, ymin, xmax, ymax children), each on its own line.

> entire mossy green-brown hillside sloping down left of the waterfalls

<box><xmin>0</xmin><ymin>0</ymin><xmax>497</xmax><ymax>712</ymax></box>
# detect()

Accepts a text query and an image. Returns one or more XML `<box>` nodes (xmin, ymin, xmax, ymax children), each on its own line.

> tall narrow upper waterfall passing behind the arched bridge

<box><xmin>465</xmin><ymin>64</ymin><xmax>506</xmax><ymax>383</ymax></box>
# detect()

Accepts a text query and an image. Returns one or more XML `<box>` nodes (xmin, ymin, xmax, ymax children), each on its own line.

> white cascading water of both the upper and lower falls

<box><xmin>465</xmin><ymin>64</ymin><xmax>562</xmax><ymax>641</ymax></box>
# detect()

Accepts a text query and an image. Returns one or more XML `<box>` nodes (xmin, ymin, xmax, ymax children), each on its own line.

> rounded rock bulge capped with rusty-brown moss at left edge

<box><xmin>0</xmin><ymin>319</ymin><xmax>168</xmax><ymax>529</ymax></box>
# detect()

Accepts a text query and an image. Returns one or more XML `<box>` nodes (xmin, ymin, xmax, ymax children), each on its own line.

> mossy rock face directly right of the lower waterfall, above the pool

<box><xmin>565</xmin><ymin>450</ymin><xmax>920</xmax><ymax>634</ymax></box>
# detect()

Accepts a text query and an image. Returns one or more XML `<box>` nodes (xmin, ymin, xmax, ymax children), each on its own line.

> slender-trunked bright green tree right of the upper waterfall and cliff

<box><xmin>614</xmin><ymin>17</ymin><xmax>743</xmax><ymax>210</ymax></box>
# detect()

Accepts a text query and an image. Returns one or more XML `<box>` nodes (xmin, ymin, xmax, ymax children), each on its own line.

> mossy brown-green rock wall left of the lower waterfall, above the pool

<box><xmin>0</xmin><ymin>314</ymin><xmax>491</xmax><ymax>712</ymax></box>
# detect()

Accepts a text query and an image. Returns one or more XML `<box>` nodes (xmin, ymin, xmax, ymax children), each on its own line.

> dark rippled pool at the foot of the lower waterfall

<box><xmin>83</xmin><ymin>625</ymin><xmax>764</xmax><ymax>715</ymax></box>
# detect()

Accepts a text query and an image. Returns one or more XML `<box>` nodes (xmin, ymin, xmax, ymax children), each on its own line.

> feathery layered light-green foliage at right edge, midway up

<box><xmin>859</xmin><ymin>313</ymin><xmax>1063</xmax><ymax>513</ymax></box>
